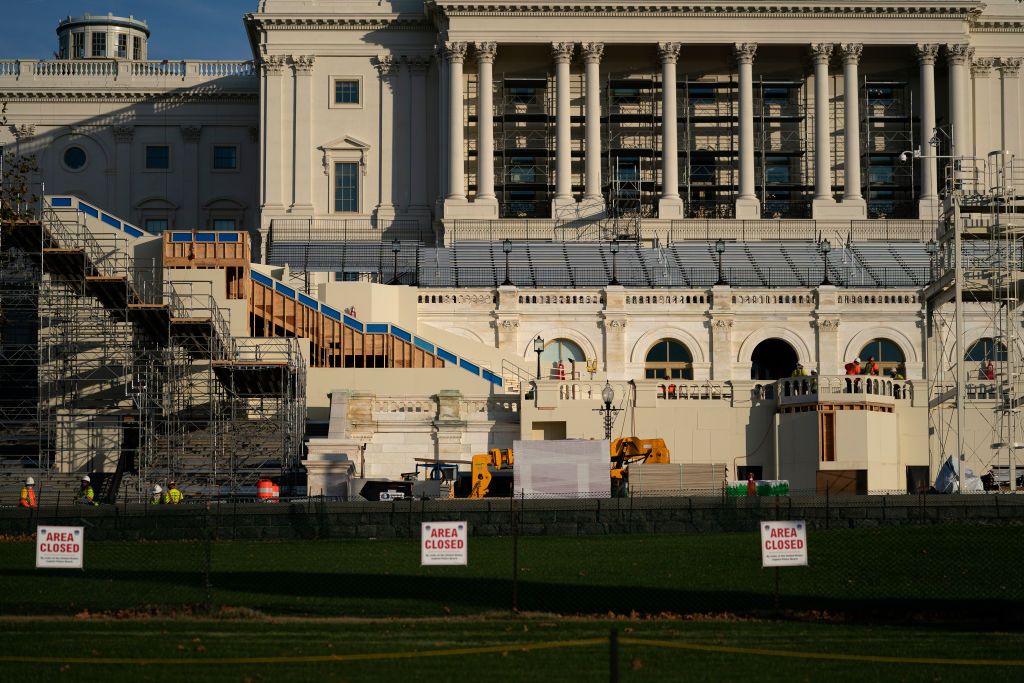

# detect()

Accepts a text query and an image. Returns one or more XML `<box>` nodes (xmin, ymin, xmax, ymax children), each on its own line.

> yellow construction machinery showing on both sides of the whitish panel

<box><xmin>455</xmin><ymin>436</ymin><xmax>670</xmax><ymax>498</ymax></box>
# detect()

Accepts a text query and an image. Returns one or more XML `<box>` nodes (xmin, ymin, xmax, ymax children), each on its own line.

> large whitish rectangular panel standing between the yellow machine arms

<box><xmin>512</xmin><ymin>439</ymin><xmax>611</xmax><ymax>498</ymax></box>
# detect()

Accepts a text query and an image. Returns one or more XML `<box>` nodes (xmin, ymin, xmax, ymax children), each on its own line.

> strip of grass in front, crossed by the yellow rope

<box><xmin>0</xmin><ymin>615</ymin><xmax>1024</xmax><ymax>683</ymax></box>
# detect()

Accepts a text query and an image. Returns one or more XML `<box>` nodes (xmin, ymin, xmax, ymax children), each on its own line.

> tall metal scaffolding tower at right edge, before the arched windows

<box><xmin>925</xmin><ymin>152</ymin><xmax>1024</xmax><ymax>490</ymax></box>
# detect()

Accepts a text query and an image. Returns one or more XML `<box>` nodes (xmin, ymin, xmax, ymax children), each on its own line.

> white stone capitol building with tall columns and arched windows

<box><xmin>0</xmin><ymin>0</ymin><xmax>1024</xmax><ymax>497</ymax></box>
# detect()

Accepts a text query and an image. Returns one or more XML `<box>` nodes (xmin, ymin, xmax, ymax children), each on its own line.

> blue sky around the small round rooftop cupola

<box><xmin>0</xmin><ymin>0</ymin><xmax>257</xmax><ymax>59</ymax></box>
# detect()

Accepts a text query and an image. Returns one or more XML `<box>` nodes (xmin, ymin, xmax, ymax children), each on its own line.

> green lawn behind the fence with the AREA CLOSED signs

<box><xmin>0</xmin><ymin>525</ymin><xmax>1024</xmax><ymax>620</ymax></box>
